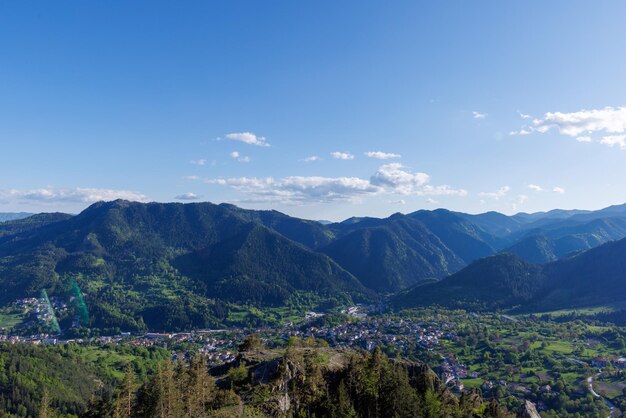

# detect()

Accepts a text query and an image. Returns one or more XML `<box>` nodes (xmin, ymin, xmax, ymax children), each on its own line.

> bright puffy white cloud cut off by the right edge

<box><xmin>510</xmin><ymin>106</ymin><xmax>626</xmax><ymax>149</ymax></box>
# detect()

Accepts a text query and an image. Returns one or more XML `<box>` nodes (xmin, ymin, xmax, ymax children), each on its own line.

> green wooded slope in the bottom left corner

<box><xmin>0</xmin><ymin>344</ymin><xmax>168</xmax><ymax>417</ymax></box>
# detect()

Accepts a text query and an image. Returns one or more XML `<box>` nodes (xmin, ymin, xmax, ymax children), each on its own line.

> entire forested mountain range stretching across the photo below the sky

<box><xmin>0</xmin><ymin>200</ymin><xmax>626</xmax><ymax>329</ymax></box>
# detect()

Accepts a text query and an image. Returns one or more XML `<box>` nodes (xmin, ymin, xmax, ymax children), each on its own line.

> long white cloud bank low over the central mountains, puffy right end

<box><xmin>206</xmin><ymin>163</ymin><xmax>467</xmax><ymax>205</ymax></box>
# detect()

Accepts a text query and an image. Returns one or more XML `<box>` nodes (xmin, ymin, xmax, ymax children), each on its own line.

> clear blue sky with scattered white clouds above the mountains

<box><xmin>0</xmin><ymin>1</ymin><xmax>626</xmax><ymax>220</ymax></box>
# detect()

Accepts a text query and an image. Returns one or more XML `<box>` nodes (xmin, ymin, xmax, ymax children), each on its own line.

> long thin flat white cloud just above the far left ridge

<box><xmin>0</xmin><ymin>187</ymin><xmax>148</xmax><ymax>204</ymax></box>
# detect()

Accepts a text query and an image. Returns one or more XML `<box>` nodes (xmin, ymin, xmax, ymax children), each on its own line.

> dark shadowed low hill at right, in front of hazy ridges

<box><xmin>394</xmin><ymin>233</ymin><xmax>626</xmax><ymax>311</ymax></box>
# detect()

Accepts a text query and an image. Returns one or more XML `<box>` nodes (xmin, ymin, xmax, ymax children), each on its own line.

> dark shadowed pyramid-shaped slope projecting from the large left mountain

<box><xmin>173</xmin><ymin>224</ymin><xmax>369</xmax><ymax>304</ymax></box>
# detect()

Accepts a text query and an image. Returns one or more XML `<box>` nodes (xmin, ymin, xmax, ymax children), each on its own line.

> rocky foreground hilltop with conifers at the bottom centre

<box><xmin>83</xmin><ymin>340</ymin><xmax>509</xmax><ymax>418</ymax></box>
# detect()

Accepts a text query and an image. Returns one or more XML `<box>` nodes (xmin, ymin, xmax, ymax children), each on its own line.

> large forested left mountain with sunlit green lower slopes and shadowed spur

<box><xmin>0</xmin><ymin>201</ymin><xmax>371</xmax><ymax>329</ymax></box>
